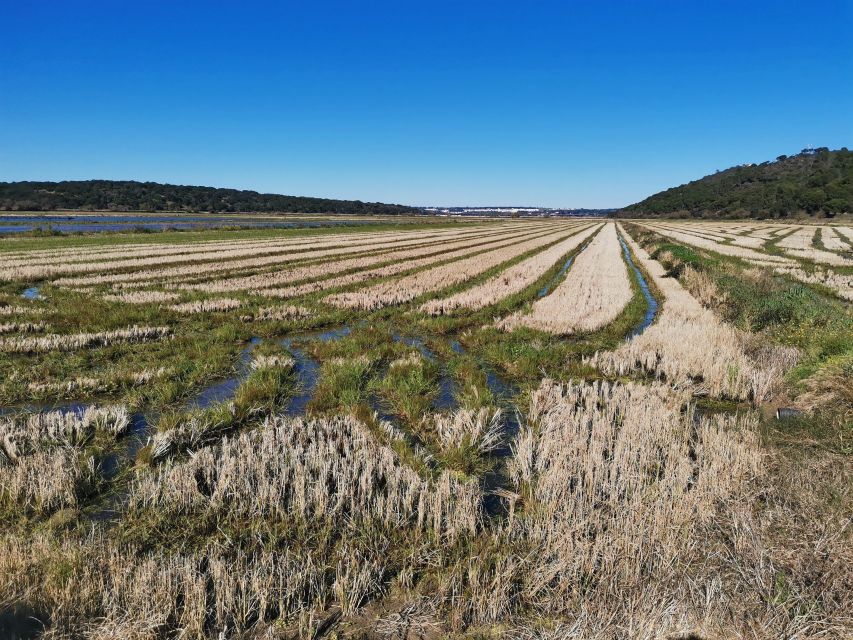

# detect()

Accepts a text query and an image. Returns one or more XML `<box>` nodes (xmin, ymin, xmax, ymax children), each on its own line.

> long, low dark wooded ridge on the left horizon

<box><xmin>0</xmin><ymin>180</ymin><xmax>419</xmax><ymax>214</ymax></box>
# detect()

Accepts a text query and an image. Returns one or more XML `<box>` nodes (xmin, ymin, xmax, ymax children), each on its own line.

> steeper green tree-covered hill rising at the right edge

<box><xmin>618</xmin><ymin>148</ymin><xmax>853</xmax><ymax>218</ymax></box>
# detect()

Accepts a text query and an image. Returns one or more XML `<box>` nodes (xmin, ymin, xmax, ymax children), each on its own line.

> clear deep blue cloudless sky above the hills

<box><xmin>0</xmin><ymin>0</ymin><xmax>853</xmax><ymax>207</ymax></box>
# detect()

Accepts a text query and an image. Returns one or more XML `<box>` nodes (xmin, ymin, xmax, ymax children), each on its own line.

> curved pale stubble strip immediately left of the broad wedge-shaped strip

<box><xmin>420</xmin><ymin>226</ymin><xmax>599</xmax><ymax>315</ymax></box>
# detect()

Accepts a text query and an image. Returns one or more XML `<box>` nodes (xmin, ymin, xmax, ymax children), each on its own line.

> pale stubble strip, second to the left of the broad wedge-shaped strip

<box><xmin>323</xmin><ymin>227</ymin><xmax>584</xmax><ymax>309</ymax></box>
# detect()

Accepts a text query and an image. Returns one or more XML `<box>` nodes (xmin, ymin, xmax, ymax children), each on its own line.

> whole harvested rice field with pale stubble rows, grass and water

<box><xmin>0</xmin><ymin>217</ymin><xmax>853</xmax><ymax>640</ymax></box>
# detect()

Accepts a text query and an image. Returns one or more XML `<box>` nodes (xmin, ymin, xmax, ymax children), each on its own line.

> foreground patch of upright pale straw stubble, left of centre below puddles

<box><xmin>129</xmin><ymin>417</ymin><xmax>481</xmax><ymax>541</ymax></box>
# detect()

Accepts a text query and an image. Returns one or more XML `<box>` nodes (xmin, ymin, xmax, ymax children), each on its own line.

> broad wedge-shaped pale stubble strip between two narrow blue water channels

<box><xmin>498</xmin><ymin>223</ymin><xmax>634</xmax><ymax>334</ymax></box>
